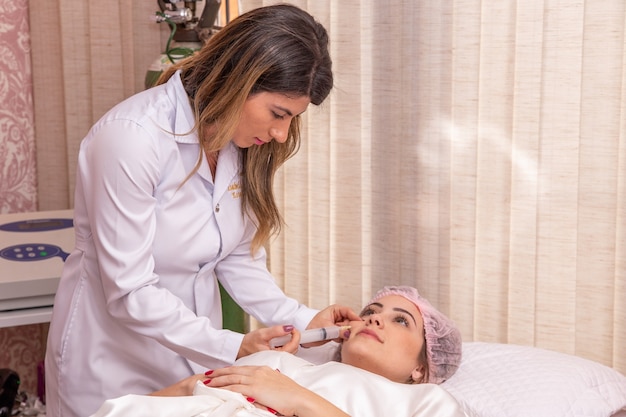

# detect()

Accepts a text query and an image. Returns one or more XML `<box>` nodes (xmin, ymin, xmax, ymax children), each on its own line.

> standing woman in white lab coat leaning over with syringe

<box><xmin>45</xmin><ymin>5</ymin><xmax>358</xmax><ymax>417</ymax></box>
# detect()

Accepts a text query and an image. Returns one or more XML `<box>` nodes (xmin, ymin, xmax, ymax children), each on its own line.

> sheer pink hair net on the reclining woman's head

<box><xmin>370</xmin><ymin>286</ymin><xmax>462</xmax><ymax>384</ymax></box>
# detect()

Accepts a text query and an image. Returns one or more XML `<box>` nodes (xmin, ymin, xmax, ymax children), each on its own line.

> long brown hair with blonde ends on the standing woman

<box><xmin>158</xmin><ymin>4</ymin><xmax>333</xmax><ymax>252</ymax></box>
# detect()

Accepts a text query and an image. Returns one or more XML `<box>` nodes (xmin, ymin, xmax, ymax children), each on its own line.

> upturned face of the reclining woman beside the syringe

<box><xmin>341</xmin><ymin>295</ymin><xmax>424</xmax><ymax>383</ymax></box>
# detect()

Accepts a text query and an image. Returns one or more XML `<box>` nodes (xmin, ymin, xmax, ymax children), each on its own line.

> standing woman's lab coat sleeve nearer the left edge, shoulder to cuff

<box><xmin>79</xmin><ymin>118</ymin><xmax>243</xmax><ymax>365</ymax></box>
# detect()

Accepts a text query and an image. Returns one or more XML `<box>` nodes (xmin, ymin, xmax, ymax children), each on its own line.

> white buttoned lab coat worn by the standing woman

<box><xmin>46</xmin><ymin>74</ymin><xmax>317</xmax><ymax>417</ymax></box>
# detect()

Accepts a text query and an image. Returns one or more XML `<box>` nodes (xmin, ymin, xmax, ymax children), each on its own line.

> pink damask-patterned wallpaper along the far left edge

<box><xmin>0</xmin><ymin>0</ymin><xmax>48</xmax><ymax>394</ymax></box>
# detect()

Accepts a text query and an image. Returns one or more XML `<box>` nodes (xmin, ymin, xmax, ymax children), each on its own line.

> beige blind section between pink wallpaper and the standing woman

<box><xmin>29</xmin><ymin>0</ymin><xmax>162</xmax><ymax>210</ymax></box>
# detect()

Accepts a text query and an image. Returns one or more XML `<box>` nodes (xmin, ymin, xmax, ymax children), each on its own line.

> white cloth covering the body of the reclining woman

<box><xmin>92</xmin><ymin>351</ymin><xmax>465</xmax><ymax>417</ymax></box>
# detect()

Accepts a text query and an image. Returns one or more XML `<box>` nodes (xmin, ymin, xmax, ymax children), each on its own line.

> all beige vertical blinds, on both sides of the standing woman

<box><xmin>30</xmin><ymin>0</ymin><xmax>626</xmax><ymax>372</ymax></box>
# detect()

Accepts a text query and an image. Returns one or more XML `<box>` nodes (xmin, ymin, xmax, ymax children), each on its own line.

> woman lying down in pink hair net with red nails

<box><xmin>93</xmin><ymin>286</ymin><xmax>464</xmax><ymax>417</ymax></box>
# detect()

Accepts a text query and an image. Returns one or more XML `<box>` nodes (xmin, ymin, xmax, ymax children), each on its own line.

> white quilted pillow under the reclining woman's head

<box><xmin>442</xmin><ymin>342</ymin><xmax>626</xmax><ymax>417</ymax></box>
